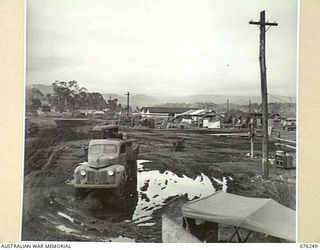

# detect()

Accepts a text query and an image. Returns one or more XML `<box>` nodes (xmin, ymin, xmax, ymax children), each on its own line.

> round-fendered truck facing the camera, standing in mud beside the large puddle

<box><xmin>74</xmin><ymin>125</ymin><xmax>139</xmax><ymax>198</ymax></box>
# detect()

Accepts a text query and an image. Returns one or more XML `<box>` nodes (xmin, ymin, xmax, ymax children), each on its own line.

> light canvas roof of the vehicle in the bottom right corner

<box><xmin>182</xmin><ymin>191</ymin><xmax>296</xmax><ymax>242</ymax></box>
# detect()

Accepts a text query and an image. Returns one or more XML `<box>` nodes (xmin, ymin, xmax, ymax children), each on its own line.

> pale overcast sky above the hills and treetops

<box><xmin>26</xmin><ymin>0</ymin><xmax>297</xmax><ymax>96</ymax></box>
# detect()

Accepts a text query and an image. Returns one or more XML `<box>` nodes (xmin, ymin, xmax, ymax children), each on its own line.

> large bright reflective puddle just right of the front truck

<box><xmin>132</xmin><ymin>160</ymin><xmax>218</xmax><ymax>226</ymax></box>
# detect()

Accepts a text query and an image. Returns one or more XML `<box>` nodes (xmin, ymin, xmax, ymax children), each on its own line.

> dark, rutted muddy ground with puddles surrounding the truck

<box><xmin>22</xmin><ymin>119</ymin><xmax>295</xmax><ymax>242</ymax></box>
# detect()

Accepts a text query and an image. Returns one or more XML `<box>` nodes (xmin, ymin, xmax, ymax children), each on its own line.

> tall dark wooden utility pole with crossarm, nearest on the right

<box><xmin>249</xmin><ymin>10</ymin><xmax>278</xmax><ymax>179</ymax></box>
